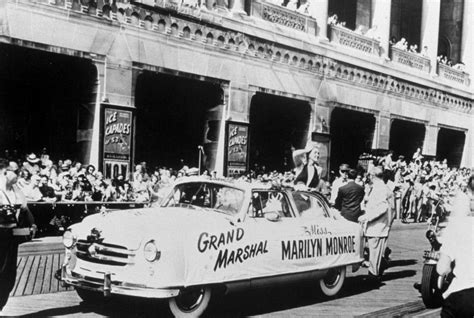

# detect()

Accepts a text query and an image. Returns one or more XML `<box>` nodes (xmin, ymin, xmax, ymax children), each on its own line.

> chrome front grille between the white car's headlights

<box><xmin>76</xmin><ymin>240</ymin><xmax>135</xmax><ymax>266</ymax></box>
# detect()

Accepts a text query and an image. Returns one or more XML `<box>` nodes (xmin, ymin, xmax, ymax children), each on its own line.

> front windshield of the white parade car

<box><xmin>162</xmin><ymin>182</ymin><xmax>244</xmax><ymax>215</ymax></box>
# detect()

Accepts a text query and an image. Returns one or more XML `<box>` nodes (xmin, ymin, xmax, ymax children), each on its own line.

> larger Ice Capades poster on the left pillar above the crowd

<box><xmin>102</xmin><ymin>107</ymin><xmax>134</xmax><ymax>179</ymax></box>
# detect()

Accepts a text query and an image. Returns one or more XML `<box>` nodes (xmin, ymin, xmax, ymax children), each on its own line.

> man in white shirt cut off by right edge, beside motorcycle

<box><xmin>436</xmin><ymin>176</ymin><xmax>474</xmax><ymax>317</ymax></box>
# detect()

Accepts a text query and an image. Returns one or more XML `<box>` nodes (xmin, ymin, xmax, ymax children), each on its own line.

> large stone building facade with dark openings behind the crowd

<box><xmin>0</xmin><ymin>0</ymin><xmax>474</xmax><ymax>176</ymax></box>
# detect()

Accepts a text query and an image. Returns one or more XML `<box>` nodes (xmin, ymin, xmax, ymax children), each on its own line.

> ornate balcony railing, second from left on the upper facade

<box><xmin>330</xmin><ymin>25</ymin><xmax>380</xmax><ymax>56</ymax></box>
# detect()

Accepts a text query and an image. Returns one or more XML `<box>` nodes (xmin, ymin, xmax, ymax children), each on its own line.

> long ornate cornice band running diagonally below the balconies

<box><xmin>6</xmin><ymin>0</ymin><xmax>473</xmax><ymax>114</ymax></box>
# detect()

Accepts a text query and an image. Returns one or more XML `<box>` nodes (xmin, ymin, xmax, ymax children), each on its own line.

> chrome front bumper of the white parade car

<box><xmin>61</xmin><ymin>265</ymin><xmax>180</xmax><ymax>298</ymax></box>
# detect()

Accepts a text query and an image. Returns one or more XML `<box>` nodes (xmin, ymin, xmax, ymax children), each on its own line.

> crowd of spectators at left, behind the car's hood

<box><xmin>6</xmin><ymin>151</ymin><xmax>207</xmax><ymax>203</ymax></box>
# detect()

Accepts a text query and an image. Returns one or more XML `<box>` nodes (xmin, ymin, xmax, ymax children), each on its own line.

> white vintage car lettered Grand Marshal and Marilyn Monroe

<box><xmin>61</xmin><ymin>178</ymin><xmax>363</xmax><ymax>317</ymax></box>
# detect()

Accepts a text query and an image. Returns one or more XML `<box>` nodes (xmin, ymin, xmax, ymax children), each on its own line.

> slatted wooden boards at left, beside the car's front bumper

<box><xmin>10</xmin><ymin>253</ymin><xmax>71</xmax><ymax>297</ymax></box>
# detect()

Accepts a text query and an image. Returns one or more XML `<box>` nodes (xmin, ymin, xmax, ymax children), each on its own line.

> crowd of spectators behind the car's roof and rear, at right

<box><xmin>240</xmin><ymin>148</ymin><xmax>472</xmax><ymax>222</ymax></box>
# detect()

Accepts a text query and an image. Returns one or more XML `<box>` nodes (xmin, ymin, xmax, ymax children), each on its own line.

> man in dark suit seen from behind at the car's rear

<box><xmin>334</xmin><ymin>169</ymin><xmax>364</xmax><ymax>223</ymax></box>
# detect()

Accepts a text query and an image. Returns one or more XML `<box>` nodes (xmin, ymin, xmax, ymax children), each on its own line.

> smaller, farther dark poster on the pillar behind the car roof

<box><xmin>224</xmin><ymin>121</ymin><xmax>249</xmax><ymax>177</ymax></box>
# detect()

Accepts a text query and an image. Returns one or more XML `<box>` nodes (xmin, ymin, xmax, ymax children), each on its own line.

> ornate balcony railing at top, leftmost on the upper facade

<box><xmin>252</xmin><ymin>0</ymin><xmax>317</xmax><ymax>35</ymax></box>
